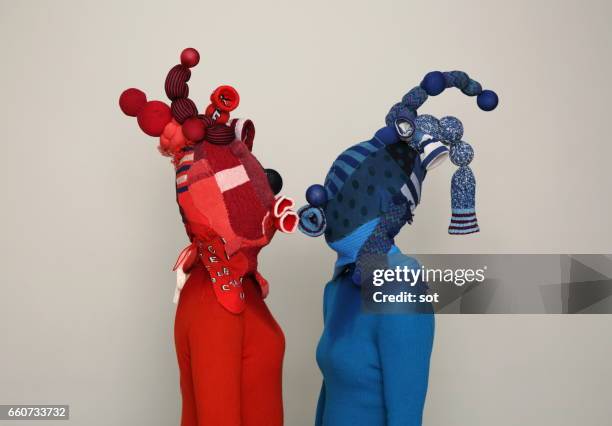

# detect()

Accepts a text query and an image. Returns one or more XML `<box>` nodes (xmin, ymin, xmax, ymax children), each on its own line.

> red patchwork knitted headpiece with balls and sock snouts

<box><xmin>119</xmin><ymin>48</ymin><xmax>297</xmax><ymax>313</ymax></box>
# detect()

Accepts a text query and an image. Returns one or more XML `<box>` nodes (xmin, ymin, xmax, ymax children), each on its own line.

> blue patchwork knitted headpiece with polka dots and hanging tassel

<box><xmin>298</xmin><ymin>71</ymin><xmax>498</xmax><ymax>281</ymax></box>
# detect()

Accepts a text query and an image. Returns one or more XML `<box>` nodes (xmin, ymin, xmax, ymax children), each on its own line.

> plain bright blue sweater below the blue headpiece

<box><xmin>315</xmin><ymin>253</ymin><xmax>434</xmax><ymax>426</ymax></box>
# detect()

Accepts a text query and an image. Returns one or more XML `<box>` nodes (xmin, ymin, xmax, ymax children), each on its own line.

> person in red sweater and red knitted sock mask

<box><xmin>119</xmin><ymin>49</ymin><xmax>297</xmax><ymax>426</ymax></box>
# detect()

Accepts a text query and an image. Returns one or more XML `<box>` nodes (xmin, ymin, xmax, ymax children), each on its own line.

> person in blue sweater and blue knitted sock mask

<box><xmin>298</xmin><ymin>71</ymin><xmax>498</xmax><ymax>426</ymax></box>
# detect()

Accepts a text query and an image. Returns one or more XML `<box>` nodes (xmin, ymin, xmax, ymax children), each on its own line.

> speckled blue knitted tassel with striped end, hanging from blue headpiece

<box><xmin>448</xmin><ymin>141</ymin><xmax>480</xmax><ymax>235</ymax></box>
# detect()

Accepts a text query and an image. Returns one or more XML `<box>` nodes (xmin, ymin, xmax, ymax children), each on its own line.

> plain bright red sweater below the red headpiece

<box><xmin>174</xmin><ymin>266</ymin><xmax>285</xmax><ymax>426</ymax></box>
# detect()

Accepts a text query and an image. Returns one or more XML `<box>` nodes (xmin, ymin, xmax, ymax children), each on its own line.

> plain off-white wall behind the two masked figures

<box><xmin>0</xmin><ymin>0</ymin><xmax>612</xmax><ymax>426</ymax></box>
